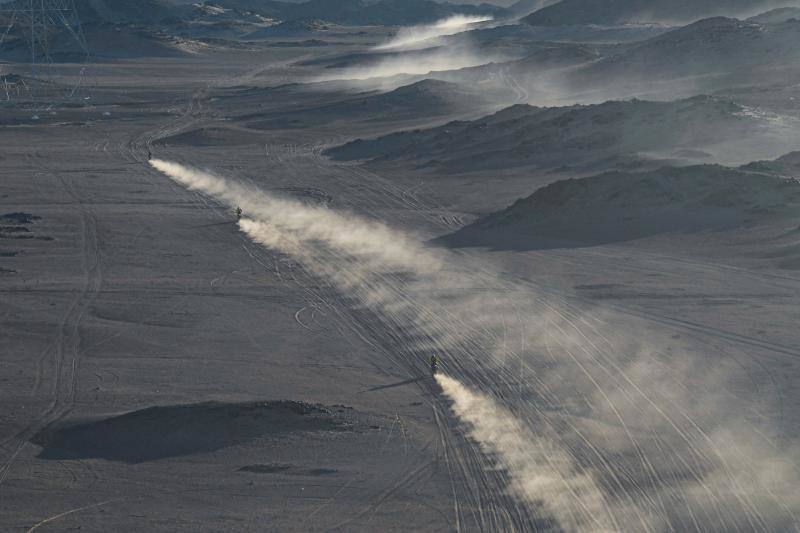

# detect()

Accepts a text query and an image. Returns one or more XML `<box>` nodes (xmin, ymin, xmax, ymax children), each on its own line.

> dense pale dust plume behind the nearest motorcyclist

<box><xmin>436</xmin><ymin>374</ymin><xmax>620</xmax><ymax>533</ymax></box>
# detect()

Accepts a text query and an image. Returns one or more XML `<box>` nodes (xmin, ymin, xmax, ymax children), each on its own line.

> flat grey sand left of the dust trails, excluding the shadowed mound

<box><xmin>0</xmin><ymin>53</ymin><xmax>457</xmax><ymax>531</ymax></box>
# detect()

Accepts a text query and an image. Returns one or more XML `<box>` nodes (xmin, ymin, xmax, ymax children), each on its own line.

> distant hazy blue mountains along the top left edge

<box><xmin>0</xmin><ymin>0</ymin><xmax>507</xmax><ymax>61</ymax></box>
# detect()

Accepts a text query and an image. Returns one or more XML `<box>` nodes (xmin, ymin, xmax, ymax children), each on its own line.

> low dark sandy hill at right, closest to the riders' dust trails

<box><xmin>443</xmin><ymin>152</ymin><xmax>800</xmax><ymax>249</ymax></box>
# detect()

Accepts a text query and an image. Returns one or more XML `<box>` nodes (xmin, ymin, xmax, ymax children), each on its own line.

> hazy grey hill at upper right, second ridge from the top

<box><xmin>554</xmin><ymin>17</ymin><xmax>800</xmax><ymax>99</ymax></box>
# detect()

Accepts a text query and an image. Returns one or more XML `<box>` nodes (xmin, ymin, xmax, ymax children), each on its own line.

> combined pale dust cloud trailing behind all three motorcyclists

<box><xmin>151</xmin><ymin>160</ymin><xmax>800</xmax><ymax>532</ymax></box>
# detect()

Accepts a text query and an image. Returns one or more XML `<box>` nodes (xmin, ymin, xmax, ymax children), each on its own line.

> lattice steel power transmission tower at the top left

<box><xmin>0</xmin><ymin>0</ymin><xmax>89</xmax><ymax>108</ymax></box>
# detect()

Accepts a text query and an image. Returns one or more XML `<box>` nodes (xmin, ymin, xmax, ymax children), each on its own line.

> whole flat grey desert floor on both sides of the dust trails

<box><xmin>0</xmin><ymin>42</ymin><xmax>800</xmax><ymax>531</ymax></box>
